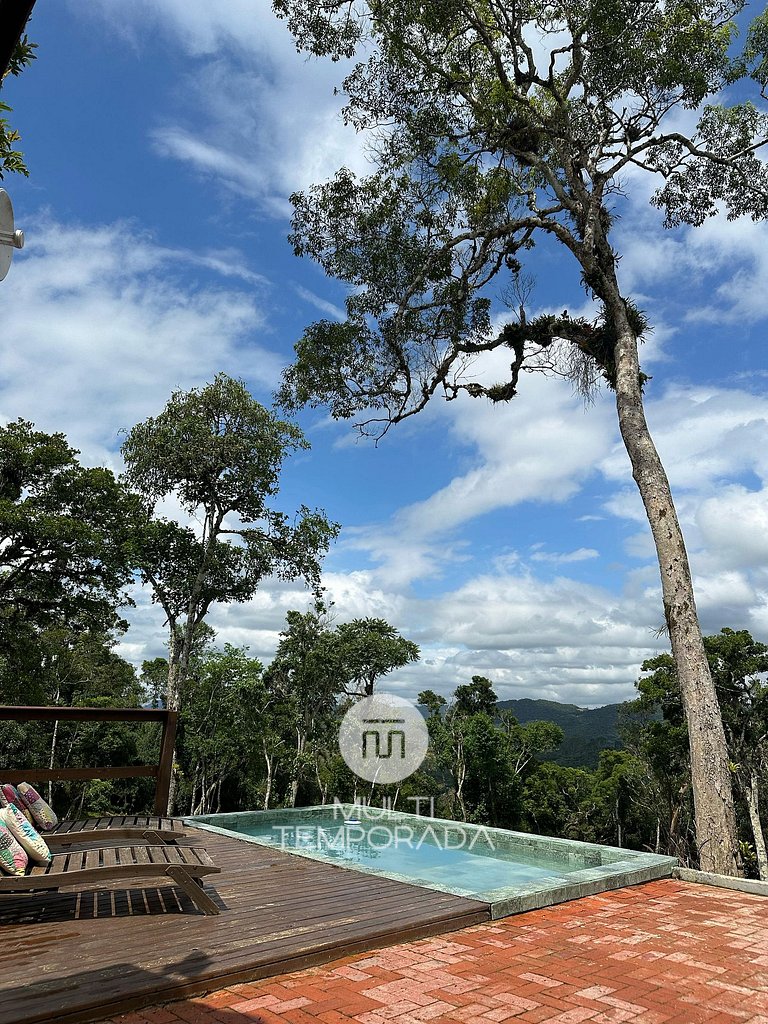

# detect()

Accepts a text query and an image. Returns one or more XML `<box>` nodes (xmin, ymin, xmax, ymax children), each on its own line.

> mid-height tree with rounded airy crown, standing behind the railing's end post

<box><xmin>122</xmin><ymin>374</ymin><xmax>338</xmax><ymax>720</ymax></box>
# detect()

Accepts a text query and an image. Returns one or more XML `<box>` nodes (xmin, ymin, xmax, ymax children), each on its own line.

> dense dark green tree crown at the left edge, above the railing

<box><xmin>0</xmin><ymin>420</ymin><xmax>135</xmax><ymax>702</ymax></box>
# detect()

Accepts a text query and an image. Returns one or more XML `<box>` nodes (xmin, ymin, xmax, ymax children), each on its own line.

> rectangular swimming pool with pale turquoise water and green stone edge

<box><xmin>185</xmin><ymin>804</ymin><xmax>677</xmax><ymax>918</ymax></box>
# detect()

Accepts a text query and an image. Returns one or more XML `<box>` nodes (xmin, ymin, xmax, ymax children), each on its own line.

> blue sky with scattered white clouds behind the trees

<box><xmin>0</xmin><ymin>0</ymin><xmax>768</xmax><ymax>706</ymax></box>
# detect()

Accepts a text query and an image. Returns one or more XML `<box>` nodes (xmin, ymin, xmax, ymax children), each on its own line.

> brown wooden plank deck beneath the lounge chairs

<box><xmin>0</xmin><ymin>828</ymin><xmax>489</xmax><ymax>1024</ymax></box>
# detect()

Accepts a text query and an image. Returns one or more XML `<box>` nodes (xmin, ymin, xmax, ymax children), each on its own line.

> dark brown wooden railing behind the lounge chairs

<box><xmin>0</xmin><ymin>706</ymin><xmax>178</xmax><ymax>814</ymax></box>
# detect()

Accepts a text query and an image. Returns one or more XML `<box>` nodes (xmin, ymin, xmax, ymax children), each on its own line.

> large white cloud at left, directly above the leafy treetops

<box><xmin>0</xmin><ymin>221</ymin><xmax>281</xmax><ymax>463</ymax></box>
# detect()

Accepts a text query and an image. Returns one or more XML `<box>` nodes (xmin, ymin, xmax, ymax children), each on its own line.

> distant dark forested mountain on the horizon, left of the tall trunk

<box><xmin>497</xmin><ymin>697</ymin><xmax>624</xmax><ymax>768</ymax></box>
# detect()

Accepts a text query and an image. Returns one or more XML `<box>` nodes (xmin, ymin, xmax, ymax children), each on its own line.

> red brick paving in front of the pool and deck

<box><xmin>104</xmin><ymin>881</ymin><xmax>768</xmax><ymax>1024</ymax></box>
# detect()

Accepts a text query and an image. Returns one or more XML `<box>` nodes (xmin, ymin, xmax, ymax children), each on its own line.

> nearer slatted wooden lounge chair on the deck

<box><xmin>0</xmin><ymin>846</ymin><xmax>221</xmax><ymax>914</ymax></box>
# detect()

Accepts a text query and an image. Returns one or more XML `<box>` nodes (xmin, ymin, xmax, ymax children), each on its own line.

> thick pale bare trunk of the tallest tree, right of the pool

<box><xmin>604</xmin><ymin>285</ymin><xmax>739</xmax><ymax>874</ymax></box>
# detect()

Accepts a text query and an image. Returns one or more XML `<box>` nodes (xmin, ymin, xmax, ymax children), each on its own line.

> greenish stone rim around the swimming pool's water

<box><xmin>184</xmin><ymin>804</ymin><xmax>678</xmax><ymax>921</ymax></box>
